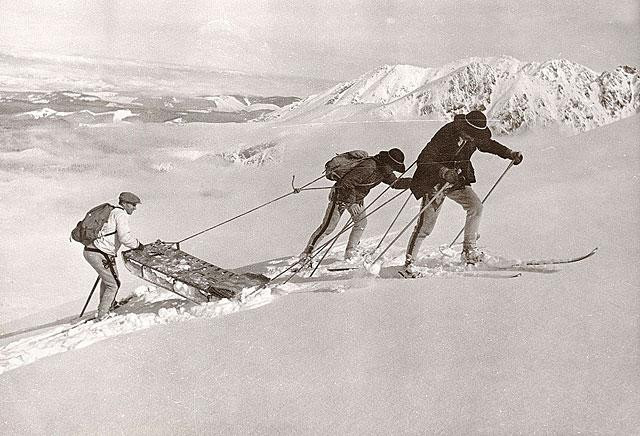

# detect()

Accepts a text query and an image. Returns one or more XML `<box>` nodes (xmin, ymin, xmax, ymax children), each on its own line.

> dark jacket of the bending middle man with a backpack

<box><xmin>331</xmin><ymin>154</ymin><xmax>411</xmax><ymax>204</ymax></box>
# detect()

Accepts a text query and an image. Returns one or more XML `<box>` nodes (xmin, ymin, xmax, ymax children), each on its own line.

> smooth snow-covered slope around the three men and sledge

<box><xmin>0</xmin><ymin>116</ymin><xmax>640</xmax><ymax>434</ymax></box>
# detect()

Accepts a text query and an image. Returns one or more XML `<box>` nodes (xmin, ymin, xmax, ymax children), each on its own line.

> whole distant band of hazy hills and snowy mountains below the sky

<box><xmin>0</xmin><ymin>52</ymin><xmax>640</xmax><ymax>134</ymax></box>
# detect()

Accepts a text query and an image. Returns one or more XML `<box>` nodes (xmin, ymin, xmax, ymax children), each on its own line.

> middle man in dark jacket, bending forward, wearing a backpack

<box><xmin>300</xmin><ymin>148</ymin><xmax>411</xmax><ymax>260</ymax></box>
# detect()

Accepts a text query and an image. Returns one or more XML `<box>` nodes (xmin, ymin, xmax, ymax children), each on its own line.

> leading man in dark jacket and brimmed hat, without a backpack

<box><xmin>405</xmin><ymin>111</ymin><xmax>522</xmax><ymax>271</ymax></box>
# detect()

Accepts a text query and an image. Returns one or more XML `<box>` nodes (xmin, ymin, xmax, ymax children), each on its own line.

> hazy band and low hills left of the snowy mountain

<box><xmin>0</xmin><ymin>46</ymin><xmax>335</xmax><ymax>128</ymax></box>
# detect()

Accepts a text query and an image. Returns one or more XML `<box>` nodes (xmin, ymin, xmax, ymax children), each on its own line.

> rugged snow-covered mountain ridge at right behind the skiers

<box><xmin>266</xmin><ymin>56</ymin><xmax>640</xmax><ymax>134</ymax></box>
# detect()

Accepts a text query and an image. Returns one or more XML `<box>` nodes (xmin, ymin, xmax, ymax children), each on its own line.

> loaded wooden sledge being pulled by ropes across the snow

<box><xmin>122</xmin><ymin>241</ymin><xmax>269</xmax><ymax>303</ymax></box>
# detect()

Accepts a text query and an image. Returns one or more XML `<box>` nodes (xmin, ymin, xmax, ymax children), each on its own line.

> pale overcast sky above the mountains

<box><xmin>0</xmin><ymin>0</ymin><xmax>640</xmax><ymax>80</ymax></box>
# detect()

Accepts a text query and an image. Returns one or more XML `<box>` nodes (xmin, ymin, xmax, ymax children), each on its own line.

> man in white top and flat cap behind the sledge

<box><xmin>83</xmin><ymin>192</ymin><xmax>144</xmax><ymax>320</ymax></box>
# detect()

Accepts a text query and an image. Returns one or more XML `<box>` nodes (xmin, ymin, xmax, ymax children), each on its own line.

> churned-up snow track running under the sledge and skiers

<box><xmin>0</xmin><ymin>232</ymin><xmax>549</xmax><ymax>374</ymax></box>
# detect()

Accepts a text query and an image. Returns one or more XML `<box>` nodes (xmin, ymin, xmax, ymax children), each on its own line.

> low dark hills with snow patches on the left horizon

<box><xmin>0</xmin><ymin>91</ymin><xmax>299</xmax><ymax>128</ymax></box>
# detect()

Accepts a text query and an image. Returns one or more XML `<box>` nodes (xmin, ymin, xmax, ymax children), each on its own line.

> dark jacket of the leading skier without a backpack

<box><xmin>411</xmin><ymin>115</ymin><xmax>511</xmax><ymax>199</ymax></box>
